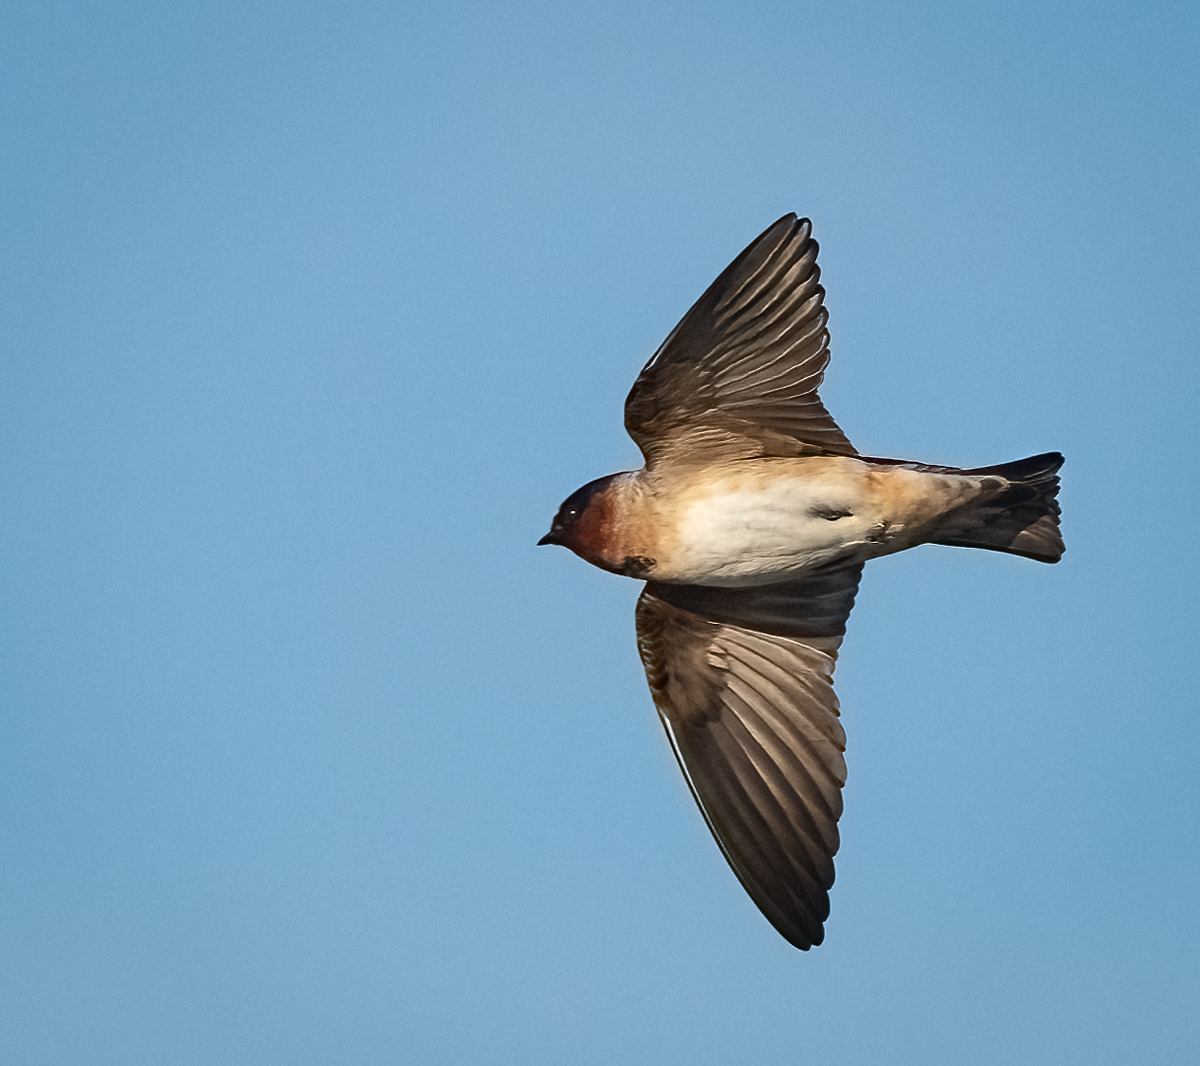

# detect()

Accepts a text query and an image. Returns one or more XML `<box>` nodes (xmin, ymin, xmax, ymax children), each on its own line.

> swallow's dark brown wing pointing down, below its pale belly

<box><xmin>637</xmin><ymin>567</ymin><xmax>862</xmax><ymax>950</ymax></box>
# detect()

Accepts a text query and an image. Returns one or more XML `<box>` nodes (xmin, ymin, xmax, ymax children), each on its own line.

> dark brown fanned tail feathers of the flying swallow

<box><xmin>932</xmin><ymin>451</ymin><xmax>1066</xmax><ymax>563</ymax></box>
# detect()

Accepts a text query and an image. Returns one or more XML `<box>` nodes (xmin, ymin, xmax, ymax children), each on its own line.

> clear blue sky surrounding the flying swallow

<box><xmin>0</xmin><ymin>0</ymin><xmax>1200</xmax><ymax>1066</ymax></box>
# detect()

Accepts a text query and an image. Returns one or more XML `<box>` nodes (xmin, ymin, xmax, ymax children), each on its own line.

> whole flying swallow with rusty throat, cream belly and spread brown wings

<box><xmin>538</xmin><ymin>214</ymin><xmax>1064</xmax><ymax>951</ymax></box>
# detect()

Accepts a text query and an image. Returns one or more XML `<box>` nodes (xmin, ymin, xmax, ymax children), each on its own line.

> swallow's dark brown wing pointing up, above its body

<box><xmin>625</xmin><ymin>215</ymin><xmax>857</xmax><ymax>463</ymax></box>
